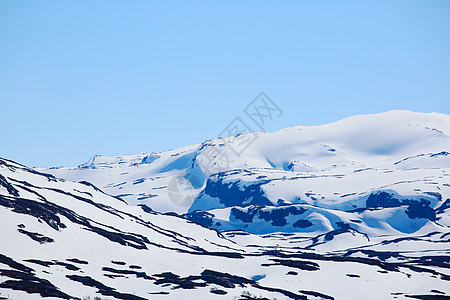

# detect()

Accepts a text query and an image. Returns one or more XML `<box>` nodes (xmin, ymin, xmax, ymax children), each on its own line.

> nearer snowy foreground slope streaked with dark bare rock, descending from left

<box><xmin>0</xmin><ymin>150</ymin><xmax>450</xmax><ymax>300</ymax></box>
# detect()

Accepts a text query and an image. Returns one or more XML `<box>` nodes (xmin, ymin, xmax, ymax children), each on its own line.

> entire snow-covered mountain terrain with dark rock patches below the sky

<box><xmin>0</xmin><ymin>111</ymin><xmax>450</xmax><ymax>299</ymax></box>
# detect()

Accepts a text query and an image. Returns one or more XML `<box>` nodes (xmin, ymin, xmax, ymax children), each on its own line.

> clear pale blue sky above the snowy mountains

<box><xmin>0</xmin><ymin>0</ymin><xmax>450</xmax><ymax>166</ymax></box>
